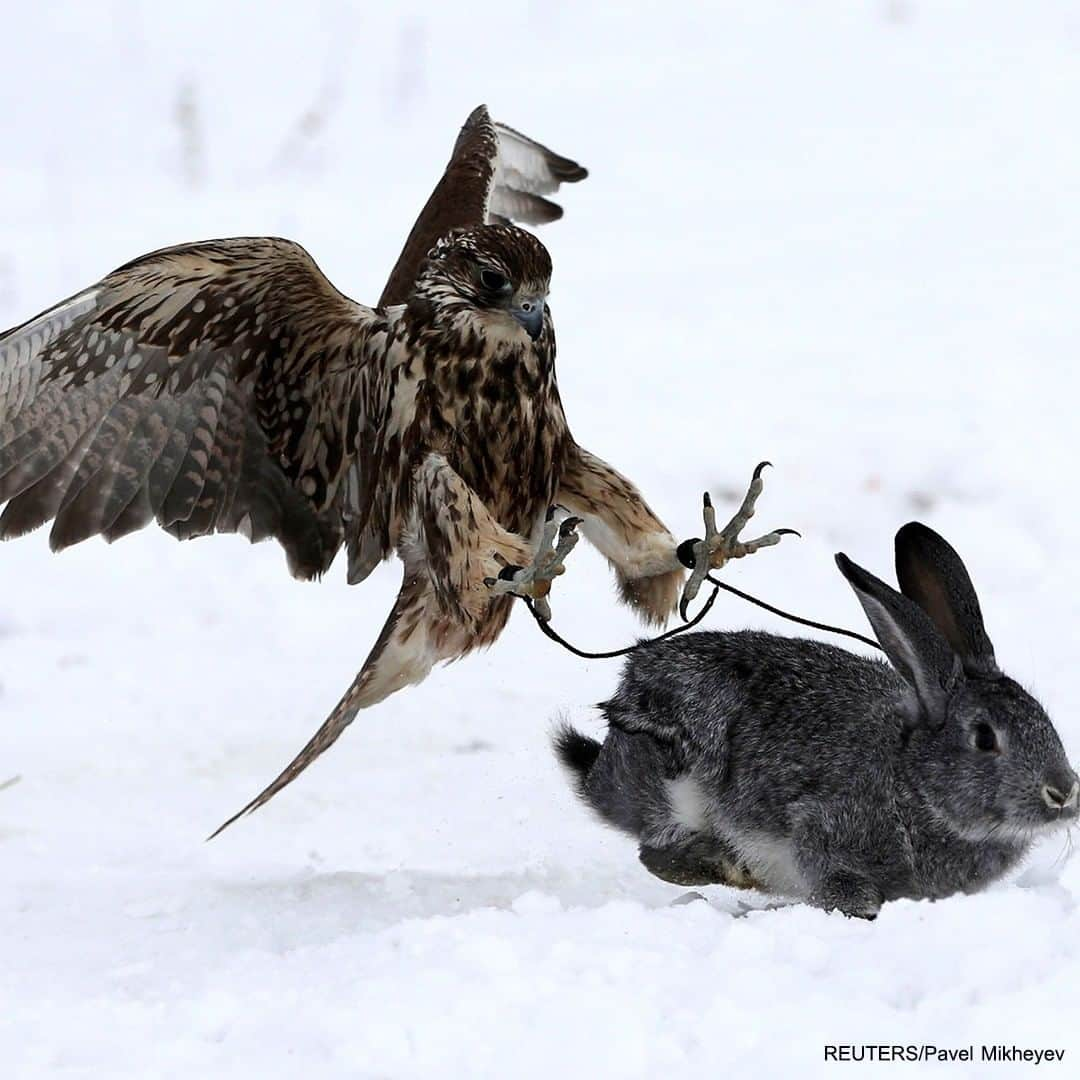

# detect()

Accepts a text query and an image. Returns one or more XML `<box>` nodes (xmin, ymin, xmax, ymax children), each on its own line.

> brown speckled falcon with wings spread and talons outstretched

<box><xmin>0</xmin><ymin>106</ymin><xmax>794</xmax><ymax>828</ymax></box>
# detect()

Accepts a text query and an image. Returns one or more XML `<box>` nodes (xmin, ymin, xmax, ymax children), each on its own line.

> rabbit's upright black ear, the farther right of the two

<box><xmin>896</xmin><ymin>522</ymin><xmax>1001</xmax><ymax>678</ymax></box>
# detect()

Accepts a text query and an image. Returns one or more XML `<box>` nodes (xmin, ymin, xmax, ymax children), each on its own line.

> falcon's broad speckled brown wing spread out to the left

<box><xmin>0</xmin><ymin>238</ymin><xmax>395</xmax><ymax>578</ymax></box>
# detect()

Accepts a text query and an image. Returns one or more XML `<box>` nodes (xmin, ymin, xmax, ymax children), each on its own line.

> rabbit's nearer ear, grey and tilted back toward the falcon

<box><xmin>836</xmin><ymin>555</ymin><xmax>960</xmax><ymax>723</ymax></box>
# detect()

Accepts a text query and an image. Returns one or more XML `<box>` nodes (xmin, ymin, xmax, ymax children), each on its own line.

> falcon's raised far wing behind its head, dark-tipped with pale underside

<box><xmin>379</xmin><ymin>105</ymin><xmax>589</xmax><ymax>307</ymax></box>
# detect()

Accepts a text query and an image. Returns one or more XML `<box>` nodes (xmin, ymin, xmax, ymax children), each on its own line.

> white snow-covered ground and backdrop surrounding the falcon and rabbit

<box><xmin>0</xmin><ymin>0</ymin><xmax>1080</xmax><ymax>1078</ymax></box>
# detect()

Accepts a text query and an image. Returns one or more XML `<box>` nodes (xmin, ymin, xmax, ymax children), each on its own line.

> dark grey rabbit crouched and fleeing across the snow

<box><xmin>554</xmin><ymin>522</ymin><xmax>1080</xmax><ymax>918</ymax></box>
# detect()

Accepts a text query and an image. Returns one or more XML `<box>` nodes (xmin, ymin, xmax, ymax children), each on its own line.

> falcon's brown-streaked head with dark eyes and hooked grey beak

<box><xmin>413</xmin><ymin>225</ymin><xmax>551</xmax><ymax>341</ymax></box>
